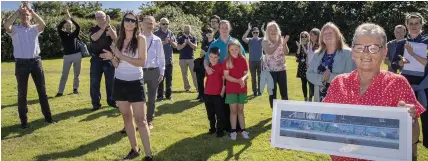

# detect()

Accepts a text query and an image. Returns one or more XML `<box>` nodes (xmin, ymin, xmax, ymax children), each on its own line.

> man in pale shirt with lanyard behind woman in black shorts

<box><xmin>141</xmin><ymin>16</ymin><xmax>165</xmax><ymax>129</ymax></box>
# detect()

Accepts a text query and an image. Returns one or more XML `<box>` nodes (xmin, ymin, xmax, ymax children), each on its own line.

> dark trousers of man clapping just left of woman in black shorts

<box><xmin>90</xmin><ymin>56</ymin><xmax>116</xmax><ymax>108</ymax></box>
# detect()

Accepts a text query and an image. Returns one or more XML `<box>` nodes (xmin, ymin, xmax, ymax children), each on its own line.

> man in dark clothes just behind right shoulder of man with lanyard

<box><xmin>154</xmin><ymin>18</ymin><xmax>177</xmax><ymax>101</ymax></box>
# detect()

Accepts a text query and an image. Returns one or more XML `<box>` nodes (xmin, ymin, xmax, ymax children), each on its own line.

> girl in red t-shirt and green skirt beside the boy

<box><xmin>223</xmin><ymin>40</ymin><xmax>249</xmax><ymax>140</ymax></box>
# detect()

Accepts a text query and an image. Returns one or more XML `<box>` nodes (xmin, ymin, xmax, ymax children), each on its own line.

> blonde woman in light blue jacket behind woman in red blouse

<box><xmin>306</xmin><ymin>22</ymin><xmax>355</xmax><ymax>102</ymax></box>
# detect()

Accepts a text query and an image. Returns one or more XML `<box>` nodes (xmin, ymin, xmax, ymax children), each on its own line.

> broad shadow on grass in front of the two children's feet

<box><xmin>155</xmin><ymin>118</ymin><xmax>271</xmax><ymax>161</ymax></box>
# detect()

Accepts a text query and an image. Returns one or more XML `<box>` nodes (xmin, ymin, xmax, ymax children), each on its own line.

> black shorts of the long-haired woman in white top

<box><xmin>112</xmin><ymin>78</ymin><xmax>146</xmax><ymax>103</ymax></box>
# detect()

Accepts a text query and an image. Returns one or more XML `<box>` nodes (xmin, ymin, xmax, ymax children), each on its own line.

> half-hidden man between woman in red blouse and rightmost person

<box><xmin>384</xmin><ymin>25</ymin><xmax>407</xmax><ymax>73</ymax></box>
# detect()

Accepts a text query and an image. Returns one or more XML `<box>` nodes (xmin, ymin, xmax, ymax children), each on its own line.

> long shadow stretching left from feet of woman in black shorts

<box><xmin>34</xmin><ymin>132</ymin><xmax>126</xmax><ymax>161</ymax></box>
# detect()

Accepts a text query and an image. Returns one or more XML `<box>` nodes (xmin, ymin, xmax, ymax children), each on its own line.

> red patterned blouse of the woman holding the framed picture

<box><xmin>323</xmin><ymin>70</ymin><xmax>425</xmax><ymax>161</ymax></box>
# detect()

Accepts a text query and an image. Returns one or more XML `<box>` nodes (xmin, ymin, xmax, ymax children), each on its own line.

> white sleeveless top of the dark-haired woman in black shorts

<box><xmin>115</xmin><ymin>48</ymin><xmax>143</xmax><ymax>81</ymax></box>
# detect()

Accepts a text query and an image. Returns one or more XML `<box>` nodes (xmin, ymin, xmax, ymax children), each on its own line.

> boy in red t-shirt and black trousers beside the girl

<box><xmin>204</xmin><ymin>48</ymin><xmax>225</xmax><ymax>137</ymax></box>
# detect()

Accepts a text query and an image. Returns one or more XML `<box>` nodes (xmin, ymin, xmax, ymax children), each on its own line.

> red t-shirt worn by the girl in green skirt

<box><xmin>223</xmin><ymin>56</ymin><xmax>248</xmax><ymax>94</ymax></box>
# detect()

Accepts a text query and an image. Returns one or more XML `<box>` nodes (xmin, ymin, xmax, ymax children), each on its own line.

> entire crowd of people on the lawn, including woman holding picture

<box><xmin>4</xmin><ymin>2</ymin><xmax>428</xmax><ymax>161</ymax></box>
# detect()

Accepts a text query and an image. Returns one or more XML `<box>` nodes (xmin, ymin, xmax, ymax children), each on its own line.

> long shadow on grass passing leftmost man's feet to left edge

<box><xmin>1</xmin><ymin>108</ymin><xmax>91</xmax><ymax>140</ymax></box>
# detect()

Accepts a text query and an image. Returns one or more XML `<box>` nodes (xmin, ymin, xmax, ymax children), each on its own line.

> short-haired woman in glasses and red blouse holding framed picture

<box><xmin>323</xmin><ymin>23</ymin><xmax>425</xmax><ymax>161</ymax></box>
